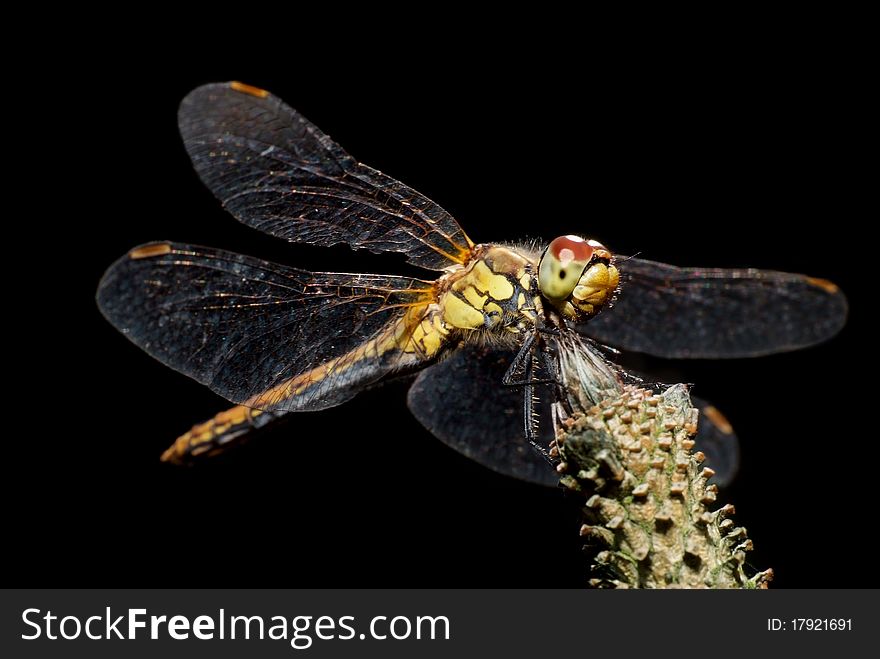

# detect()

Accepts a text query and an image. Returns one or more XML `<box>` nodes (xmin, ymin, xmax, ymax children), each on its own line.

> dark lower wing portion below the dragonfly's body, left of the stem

<box><xmin>408</xmin><ymin>345</ymin><xmax>559</xmax><ymax>486</ymax></box>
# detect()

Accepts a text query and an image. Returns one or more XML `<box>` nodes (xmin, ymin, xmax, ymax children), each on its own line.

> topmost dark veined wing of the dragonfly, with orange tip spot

<box><xmin>178</xmin><ymin>83</ymin><xmax>472</xmax><ymax>270</ymax></box>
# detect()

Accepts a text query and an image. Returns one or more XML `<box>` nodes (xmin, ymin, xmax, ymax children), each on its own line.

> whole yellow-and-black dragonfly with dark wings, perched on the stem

<box><xmin>97</xmin><ymin>82</ymin><xmax>847</xmax><ymax>485</ymax></box>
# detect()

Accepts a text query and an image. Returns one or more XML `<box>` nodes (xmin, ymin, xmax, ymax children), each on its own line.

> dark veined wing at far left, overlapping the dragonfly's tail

<box><xmin>97</xmin><ymin>243</ymin><xmax>432</xmax><ymax>411</ymax></box>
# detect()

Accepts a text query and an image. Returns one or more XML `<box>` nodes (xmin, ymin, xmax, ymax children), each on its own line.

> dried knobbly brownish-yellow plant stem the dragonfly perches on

<box><xmin>551</xmin><ymin>385</ymin><xmax>773</xmax><ymax>588</ymax></box>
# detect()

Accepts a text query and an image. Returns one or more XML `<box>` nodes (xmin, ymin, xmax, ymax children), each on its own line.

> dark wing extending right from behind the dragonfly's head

<box><xmin>580</xmin><ymin>258</ymin><xmax>847</xmax><ymax>359</ymax></box>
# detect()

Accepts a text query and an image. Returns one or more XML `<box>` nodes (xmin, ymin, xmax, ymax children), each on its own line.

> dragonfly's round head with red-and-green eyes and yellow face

<box><xmin>538</xmin><ymin>236</ymin><xmax>620</xmax><ymax>320</ymax></box>
